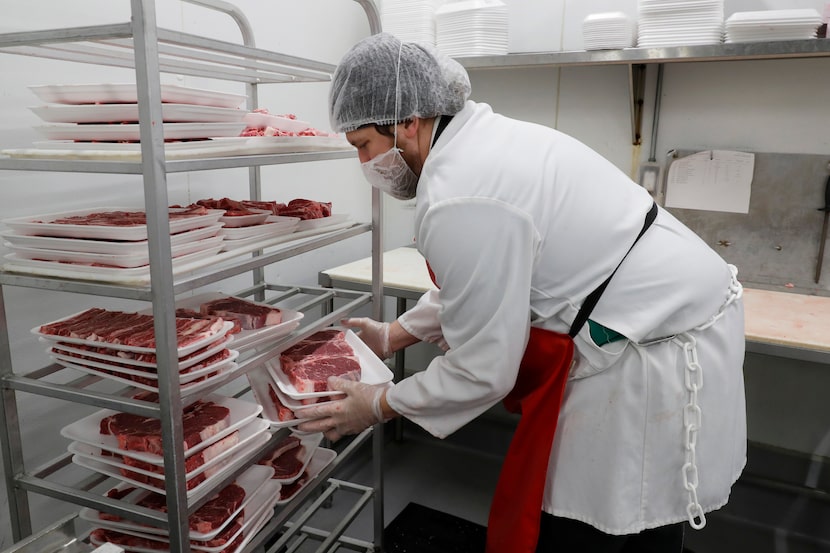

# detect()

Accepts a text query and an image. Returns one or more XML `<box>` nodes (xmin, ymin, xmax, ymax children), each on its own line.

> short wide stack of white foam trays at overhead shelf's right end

<box><xmin>726</xmin><ymin>9</ymin><xmax>822</xmax><ymax>42</ymax></box>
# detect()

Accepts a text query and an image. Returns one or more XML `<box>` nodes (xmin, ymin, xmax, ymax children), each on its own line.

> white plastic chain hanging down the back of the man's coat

<box><xmin>677</xmin><ymin>265</ymin><xmax>743</xmax><ymax>530</ymax></box>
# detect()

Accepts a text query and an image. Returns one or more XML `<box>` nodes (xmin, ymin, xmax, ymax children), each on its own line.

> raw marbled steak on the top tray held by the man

<box><xmin>280</xmin><ymin>330</ymin><xmax>361</xmax><ymax>393</ymax></box>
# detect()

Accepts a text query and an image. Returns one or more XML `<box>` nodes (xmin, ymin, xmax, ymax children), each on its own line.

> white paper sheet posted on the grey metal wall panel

<box><xmin>666</xmin><ymin>150</ymin><xmax>755</xmax><ymax>213</ymax></box>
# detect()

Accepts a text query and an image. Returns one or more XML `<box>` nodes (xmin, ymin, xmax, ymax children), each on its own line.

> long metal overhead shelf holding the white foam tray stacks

<box><xmin>456</xmin><ymin>39</ymin><xmax>830</xmax><ymax>69</ymax></box>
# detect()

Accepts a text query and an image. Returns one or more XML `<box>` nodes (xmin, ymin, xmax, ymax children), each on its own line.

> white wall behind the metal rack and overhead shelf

<box><xmin>0</xmin><ymin>0</ymin><xmax>830</xmax><ymax>548</ymax></box>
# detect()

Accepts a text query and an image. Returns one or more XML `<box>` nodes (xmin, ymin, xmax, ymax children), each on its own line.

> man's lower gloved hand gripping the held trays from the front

<box><xmin>297</xmin><ymin>376</ymin><xmax>388</xmax><ymax>441</ymax></box>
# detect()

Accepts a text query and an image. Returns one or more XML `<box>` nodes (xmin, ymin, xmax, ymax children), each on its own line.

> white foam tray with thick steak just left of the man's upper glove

<box><xmin>176</xmin><ymin>292</ymin><xmax>304</xmax><ymax>351</ymax></box>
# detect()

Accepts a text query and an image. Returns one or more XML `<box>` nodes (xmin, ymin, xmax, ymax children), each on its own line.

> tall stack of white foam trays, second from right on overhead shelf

<box><xmin>637</xmin><ymin>0</ymin><xmax>723</xmax><ymax>48</ymax></box>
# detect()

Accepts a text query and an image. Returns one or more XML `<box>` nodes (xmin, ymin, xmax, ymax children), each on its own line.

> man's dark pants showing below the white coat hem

<box><xmin>536</xmin><ymin>513</ymin><xmax>684</xmax><ymax>553</ymax></box>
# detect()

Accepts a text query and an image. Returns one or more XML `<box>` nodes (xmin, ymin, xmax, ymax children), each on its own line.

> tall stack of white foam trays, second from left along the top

<box><xmin>435</xmin><ymin>0</ymin><xmax>509</xmax><ymax>57</ymax></box>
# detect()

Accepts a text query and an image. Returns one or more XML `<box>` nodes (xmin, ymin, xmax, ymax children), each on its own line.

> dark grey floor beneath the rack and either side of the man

<box><xmin>286</xmin><ymin>416</ymin><xmax>830</xmax><ymax>553</ymax></box>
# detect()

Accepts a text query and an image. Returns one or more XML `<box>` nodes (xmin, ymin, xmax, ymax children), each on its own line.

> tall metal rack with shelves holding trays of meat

<box><xmin>0</xmin><ymin>0</ymin><xmax>383</xmax><ymax>552</ymax></box>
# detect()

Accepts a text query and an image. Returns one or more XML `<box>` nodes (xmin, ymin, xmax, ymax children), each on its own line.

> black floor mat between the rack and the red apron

<box><xmin>384</xmin><ymin>503</ymin><xmax>487</xmax><ymax>553</ymax></box>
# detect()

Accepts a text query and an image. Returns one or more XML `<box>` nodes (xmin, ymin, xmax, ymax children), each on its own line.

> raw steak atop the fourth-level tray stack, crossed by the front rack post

<box><xmin>100</xmin><ymin>400</ymin><xmax>230</xmax><ymax>455</ymax></box>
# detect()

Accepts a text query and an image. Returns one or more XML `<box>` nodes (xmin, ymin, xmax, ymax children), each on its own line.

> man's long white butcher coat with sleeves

<box><xmin>387</xmin><ymin>101</ymin><xmax>746</xmax><ymax>534</ymax></box>
